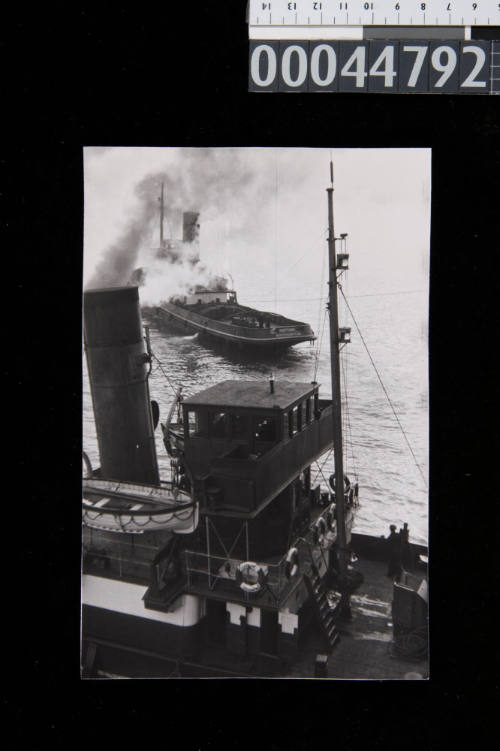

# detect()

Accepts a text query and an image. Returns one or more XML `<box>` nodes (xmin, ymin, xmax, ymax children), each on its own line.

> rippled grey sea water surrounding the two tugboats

<box><xmin>83</xmin><ymin>291</ymin><xmax>428</xmax><ymax>543</ymax></box>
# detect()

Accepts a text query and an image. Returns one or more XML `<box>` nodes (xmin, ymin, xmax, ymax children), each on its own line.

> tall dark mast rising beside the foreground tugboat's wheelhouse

<box><xmin>326</xmin><ymin>162</ymin><xmax>350</xmax><ymax>617</ymax></box>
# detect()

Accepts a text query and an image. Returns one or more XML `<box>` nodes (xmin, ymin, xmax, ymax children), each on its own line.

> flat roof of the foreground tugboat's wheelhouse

<box><xmin>183</xmin><ymin>380</ymin><xmax>317</xmax><ymax>410</ymax></box>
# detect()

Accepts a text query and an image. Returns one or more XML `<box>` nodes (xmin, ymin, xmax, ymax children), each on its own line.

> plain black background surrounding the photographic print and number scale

<box><xmin>6</xmin><ymin>1</ymin><xmax>499</xmax><ymax>751</ymax></box>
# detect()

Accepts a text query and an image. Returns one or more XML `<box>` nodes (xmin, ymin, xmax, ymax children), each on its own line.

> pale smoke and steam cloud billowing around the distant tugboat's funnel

<box><xmin>86</xmin><ymin>149</ymin><xmax>282</xmax><ymax>305</ymax></box>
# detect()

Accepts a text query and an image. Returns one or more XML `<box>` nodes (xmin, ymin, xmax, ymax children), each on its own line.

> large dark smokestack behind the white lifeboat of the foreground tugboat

<box><xmin>83</xmin><ymin>287</ymin><xmax>160</xmax><ymax>485</ymax></box>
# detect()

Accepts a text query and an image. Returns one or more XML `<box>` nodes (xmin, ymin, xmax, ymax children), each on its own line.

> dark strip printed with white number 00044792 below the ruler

<box><xmin>249</xmin><ymin>40</ymin><xmax>494</xmax><ymax>94</ymax></box>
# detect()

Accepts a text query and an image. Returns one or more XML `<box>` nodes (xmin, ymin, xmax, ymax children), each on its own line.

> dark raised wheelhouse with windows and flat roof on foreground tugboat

<box><xmin>183</xmin><ymin>381</ymin><xmax>332</xmax><ymax>516</ymax></box>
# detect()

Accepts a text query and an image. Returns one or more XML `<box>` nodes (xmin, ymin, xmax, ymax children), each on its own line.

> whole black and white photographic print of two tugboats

<box><xmin>81</xmin><ymin>144</ymin><xmax>432</xmax><ymax>681</ymax></box>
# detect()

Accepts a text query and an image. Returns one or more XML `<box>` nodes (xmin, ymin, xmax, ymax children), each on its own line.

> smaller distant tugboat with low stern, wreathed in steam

<box><xmin>137</xmin><ymin>183</ymin><xmax>316</xmax><ymax>353</ymax></box>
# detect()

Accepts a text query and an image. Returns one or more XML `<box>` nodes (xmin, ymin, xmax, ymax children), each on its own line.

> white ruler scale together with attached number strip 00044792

<box><xmin>248</xmin><ymin>0</ymin><xmax>500</xmax><ymax>94</ymax></box>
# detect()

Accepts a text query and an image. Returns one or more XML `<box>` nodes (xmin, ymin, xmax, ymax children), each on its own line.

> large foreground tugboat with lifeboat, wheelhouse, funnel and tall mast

<box><xmin>82</xmin><ymin>166</ymin><xmax>428</xmax><ymax>679</ymax></box>
